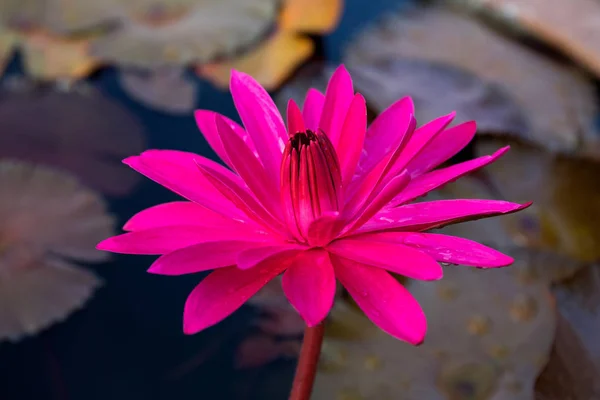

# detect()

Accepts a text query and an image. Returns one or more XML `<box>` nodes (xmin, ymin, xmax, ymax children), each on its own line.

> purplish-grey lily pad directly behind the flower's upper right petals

<box><xmin>350</xmin><ymin>58</ymin><xmax>529</xmax><ymax>133</ymax></box>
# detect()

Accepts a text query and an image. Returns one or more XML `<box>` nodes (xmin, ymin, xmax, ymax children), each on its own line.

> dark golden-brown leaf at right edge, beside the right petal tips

<box><xmin>476</xmin><ymin>140</ymin><xmax>600</xmax><ymax>262</ymax></box>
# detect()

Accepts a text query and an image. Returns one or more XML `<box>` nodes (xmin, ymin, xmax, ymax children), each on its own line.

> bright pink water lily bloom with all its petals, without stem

<box><xmin>98</xmin><ymin>67</ymin><xmax>528</xmax><ymax>344</ymax></box>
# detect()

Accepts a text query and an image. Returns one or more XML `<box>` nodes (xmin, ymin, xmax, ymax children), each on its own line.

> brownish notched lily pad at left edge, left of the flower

<box><xmin>0</xmin><ymin>160</ymin><xmax>115</xmax><ymax>341</ymax></box>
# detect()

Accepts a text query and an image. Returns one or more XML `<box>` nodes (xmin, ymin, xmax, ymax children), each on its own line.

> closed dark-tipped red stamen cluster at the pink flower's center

<box><xmin>281</xmin><ymin>131</ymin><xmax>342</xmax><ymax>241</ymax></box>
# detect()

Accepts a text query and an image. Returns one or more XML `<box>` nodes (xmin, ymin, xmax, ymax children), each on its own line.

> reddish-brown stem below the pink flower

<box><xmin>289</xmin><ymin>323</ymin><xmax>325</xmax><ymax>400</ymax></box>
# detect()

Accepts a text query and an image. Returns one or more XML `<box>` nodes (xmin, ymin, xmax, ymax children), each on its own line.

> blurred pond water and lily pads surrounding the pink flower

<box><xmin>0</xmin><ymin>0</ymin><xmax>600</xmax><ymax>400</ymax></box>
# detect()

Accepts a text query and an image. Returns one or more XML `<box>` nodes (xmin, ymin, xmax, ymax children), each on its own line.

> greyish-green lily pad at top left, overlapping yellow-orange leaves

<box><xmin>48</xmin><ymin>0</ymin><xmax>279</xmax><ymax>69</ymax></box>
